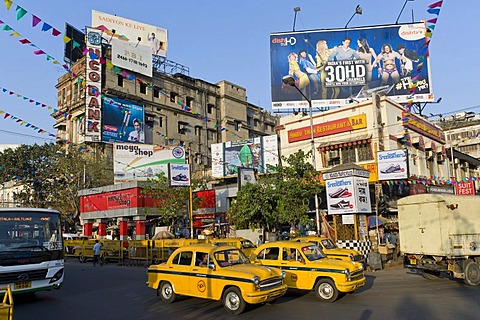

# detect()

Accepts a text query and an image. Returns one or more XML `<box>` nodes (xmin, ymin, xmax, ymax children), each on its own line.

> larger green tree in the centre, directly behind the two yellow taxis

<box><xmin>227</xmin><ymin>150</ymin><xmax>323</xmax><ymax>231</ymax></box>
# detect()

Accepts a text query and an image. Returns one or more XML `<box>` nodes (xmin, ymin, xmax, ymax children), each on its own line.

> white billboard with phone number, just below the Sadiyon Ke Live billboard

<box><xmin>111</xmin><ymin>40</ymin><xmax>153</xmax><ymax>77</ymax></box>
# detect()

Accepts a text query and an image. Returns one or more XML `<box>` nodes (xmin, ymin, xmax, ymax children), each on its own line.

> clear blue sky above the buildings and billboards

<box><xmin>0</xmin><ymin>0</ymin><xmax>474</xmax><ymax>144</ymax></box>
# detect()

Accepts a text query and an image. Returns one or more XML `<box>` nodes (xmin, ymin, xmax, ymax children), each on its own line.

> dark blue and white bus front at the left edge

<box><xmin>0</xmin><ymin>208</ymin><xmax>65</xmax><ymax>293</ymax></box>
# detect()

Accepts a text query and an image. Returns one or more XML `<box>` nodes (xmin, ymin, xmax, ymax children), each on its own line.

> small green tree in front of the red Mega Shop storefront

<box><xmin>142</xmin><ymin>172</ymin><xmax>205</xmax><ymax>226</ymax></box>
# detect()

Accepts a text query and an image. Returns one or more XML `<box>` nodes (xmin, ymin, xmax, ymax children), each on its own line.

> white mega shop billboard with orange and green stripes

<box><xmin>113</xmin><ymin>143</ymin><xmax>185</xmax><ymax>183</ymax></box>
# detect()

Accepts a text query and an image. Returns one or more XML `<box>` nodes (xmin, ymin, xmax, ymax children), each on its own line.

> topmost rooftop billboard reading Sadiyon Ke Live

<box><xmin>92</xmin><ymin>10</ymin><xmax>168</xmax><ymax>57</ymax></box>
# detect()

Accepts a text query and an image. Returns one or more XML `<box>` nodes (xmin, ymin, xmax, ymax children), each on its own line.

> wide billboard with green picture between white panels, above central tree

<box><xmin>212</xmin><ymin>135</ymin><xmax>278</xmax><ymax>178</ymax></box>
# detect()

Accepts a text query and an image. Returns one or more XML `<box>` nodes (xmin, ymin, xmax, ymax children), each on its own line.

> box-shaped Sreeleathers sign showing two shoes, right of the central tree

<box><xmin>326</xmin><ymin>176</ymin><xmax>372</xmax><ymax>214</ymax></box>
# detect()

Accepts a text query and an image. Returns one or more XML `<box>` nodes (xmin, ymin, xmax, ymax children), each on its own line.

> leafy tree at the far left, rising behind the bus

<box><xmin>0</xmin><ymin>143</ymin><xmax>113</xmax><ymax>224</ymax></box>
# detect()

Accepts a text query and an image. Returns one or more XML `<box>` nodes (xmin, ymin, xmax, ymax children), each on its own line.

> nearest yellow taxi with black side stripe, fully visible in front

<box><xmin>147</xmin><ymin>244</ymin><xmax>287</xmax><ymax>314</ymax></box>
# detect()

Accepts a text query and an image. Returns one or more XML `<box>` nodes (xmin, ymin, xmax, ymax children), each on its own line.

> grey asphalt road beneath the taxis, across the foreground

<box><xmin>14</xmin><ymin>260</ymin><xmax>480</xmax><ymax>320</ymax></box>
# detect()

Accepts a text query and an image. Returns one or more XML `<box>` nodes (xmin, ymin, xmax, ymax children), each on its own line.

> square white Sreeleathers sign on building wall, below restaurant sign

<box><xmin>377</xmin><ymin>149</ymin><xmax>408</xmax><ymax>181</ymax></box>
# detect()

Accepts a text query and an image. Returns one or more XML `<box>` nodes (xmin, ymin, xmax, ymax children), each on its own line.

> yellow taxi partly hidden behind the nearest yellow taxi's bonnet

<box><xmin>251</xmin><ymin>241</ymin><xmax>365</xmax><ymax>302</ymax></box>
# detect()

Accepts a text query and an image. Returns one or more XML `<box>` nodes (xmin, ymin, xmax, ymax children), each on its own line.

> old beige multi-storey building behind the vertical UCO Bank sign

<box><xmin>54</xmin><ymin>46</ymin><xmax>279</xmax><ymax>178</ymax></box>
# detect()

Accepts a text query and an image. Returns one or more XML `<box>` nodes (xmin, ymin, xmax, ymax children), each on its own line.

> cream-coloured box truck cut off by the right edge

<box><xmin>398</xmin><ymin>194</ymin><xmax>480</xmax><ymax>286</ymax></box>
